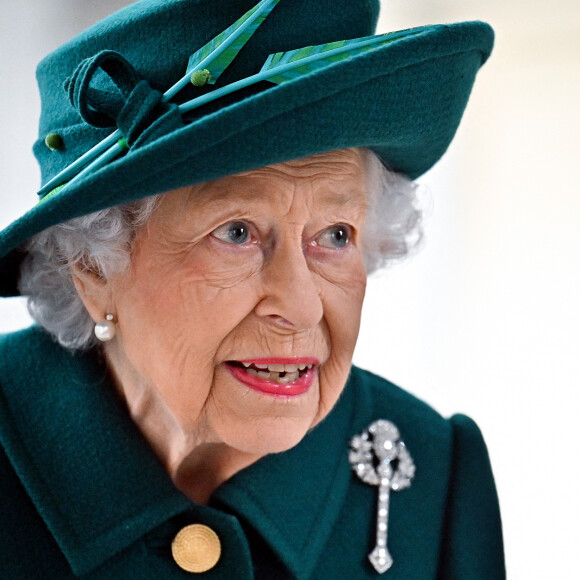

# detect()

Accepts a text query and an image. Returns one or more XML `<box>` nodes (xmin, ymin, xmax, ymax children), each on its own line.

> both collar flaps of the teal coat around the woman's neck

<box><xmin>0</xmin><ymin>328</ymin><xmax>355</xmax><ymax>579</ymax></box>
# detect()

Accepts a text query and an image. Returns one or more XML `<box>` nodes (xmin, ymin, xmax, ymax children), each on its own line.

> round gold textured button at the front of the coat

<box><xmin>171</xmin><ymin>524</ymin><xmax>222</xmax><ymax>574</ymax></box>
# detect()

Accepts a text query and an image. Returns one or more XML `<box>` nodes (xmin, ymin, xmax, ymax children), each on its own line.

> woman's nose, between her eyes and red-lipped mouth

<box><xmin>255</xmin><ymin>240</ymin><xmax>323</xmax><ymax>330</ymax></box>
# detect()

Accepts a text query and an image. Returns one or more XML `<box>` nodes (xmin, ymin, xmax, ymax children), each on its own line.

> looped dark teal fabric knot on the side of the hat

<box><xmin>65</xmin><ymin>50</ymin><xmax>184</xmax><ymax>148</ymax></box>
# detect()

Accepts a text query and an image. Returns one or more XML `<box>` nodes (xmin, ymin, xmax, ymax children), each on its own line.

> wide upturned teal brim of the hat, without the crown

<box><xmin>0</xmin><ymin>22</ymin><xmax>493</xmax><ymax>296</ymax></box>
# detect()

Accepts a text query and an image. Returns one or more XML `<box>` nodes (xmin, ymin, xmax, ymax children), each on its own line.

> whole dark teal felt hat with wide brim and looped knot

<box><xmin>0</xmin><ymin>0</ymin><xmax>493</xmax><ymax>296</ymax></box>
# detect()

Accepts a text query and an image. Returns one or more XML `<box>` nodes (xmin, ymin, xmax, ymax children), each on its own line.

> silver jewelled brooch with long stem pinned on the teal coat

<box><xmin>348</xmin><ymin>419</ymin><xmax>415</xmax><ymax>574</ymax></box>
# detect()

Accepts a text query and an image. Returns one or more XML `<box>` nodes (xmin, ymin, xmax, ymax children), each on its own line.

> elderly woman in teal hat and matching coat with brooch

<box><xmin>0</xmin><ymin>0</ymin><xmax>504</xmax><ymax>580</ymax></box>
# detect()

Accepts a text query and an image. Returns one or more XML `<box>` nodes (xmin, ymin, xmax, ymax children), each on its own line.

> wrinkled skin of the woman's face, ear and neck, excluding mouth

<box><xmin>74</xmin><ymin>150</ymin><xmax>367</xmax><ymax>502</ymax></box>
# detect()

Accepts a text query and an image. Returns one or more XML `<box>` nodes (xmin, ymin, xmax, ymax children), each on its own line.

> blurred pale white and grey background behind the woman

<box><xmin>0</xmin><ymin>0</ymin><xmax>580</xmax><ymax>580</ymax></box>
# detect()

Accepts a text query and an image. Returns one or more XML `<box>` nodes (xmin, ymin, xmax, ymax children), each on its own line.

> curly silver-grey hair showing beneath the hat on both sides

<box><xmin>19</xmin><ymin>149</ymin><xmax>421</xmax><ymax>350</ymax></box>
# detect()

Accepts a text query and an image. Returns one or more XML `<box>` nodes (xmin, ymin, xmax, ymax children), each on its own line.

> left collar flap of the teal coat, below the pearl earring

<box><xmin>0</xmin><ymin>328</ymin><xmax>188</xmax><ymax>575</ymax></box>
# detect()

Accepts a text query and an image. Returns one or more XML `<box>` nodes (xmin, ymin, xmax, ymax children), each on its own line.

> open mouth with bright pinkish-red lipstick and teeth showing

<box><xmin>225</xmin><ymin>359</ymin><xmax>318</xmax><ymax>397</ymax></box>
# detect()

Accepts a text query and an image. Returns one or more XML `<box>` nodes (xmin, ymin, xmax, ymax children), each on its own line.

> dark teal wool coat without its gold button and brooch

<box><xmin>0</xmin><ymin>328</ymin><xmax>505</xmax><ymax>580</ymax></box>
